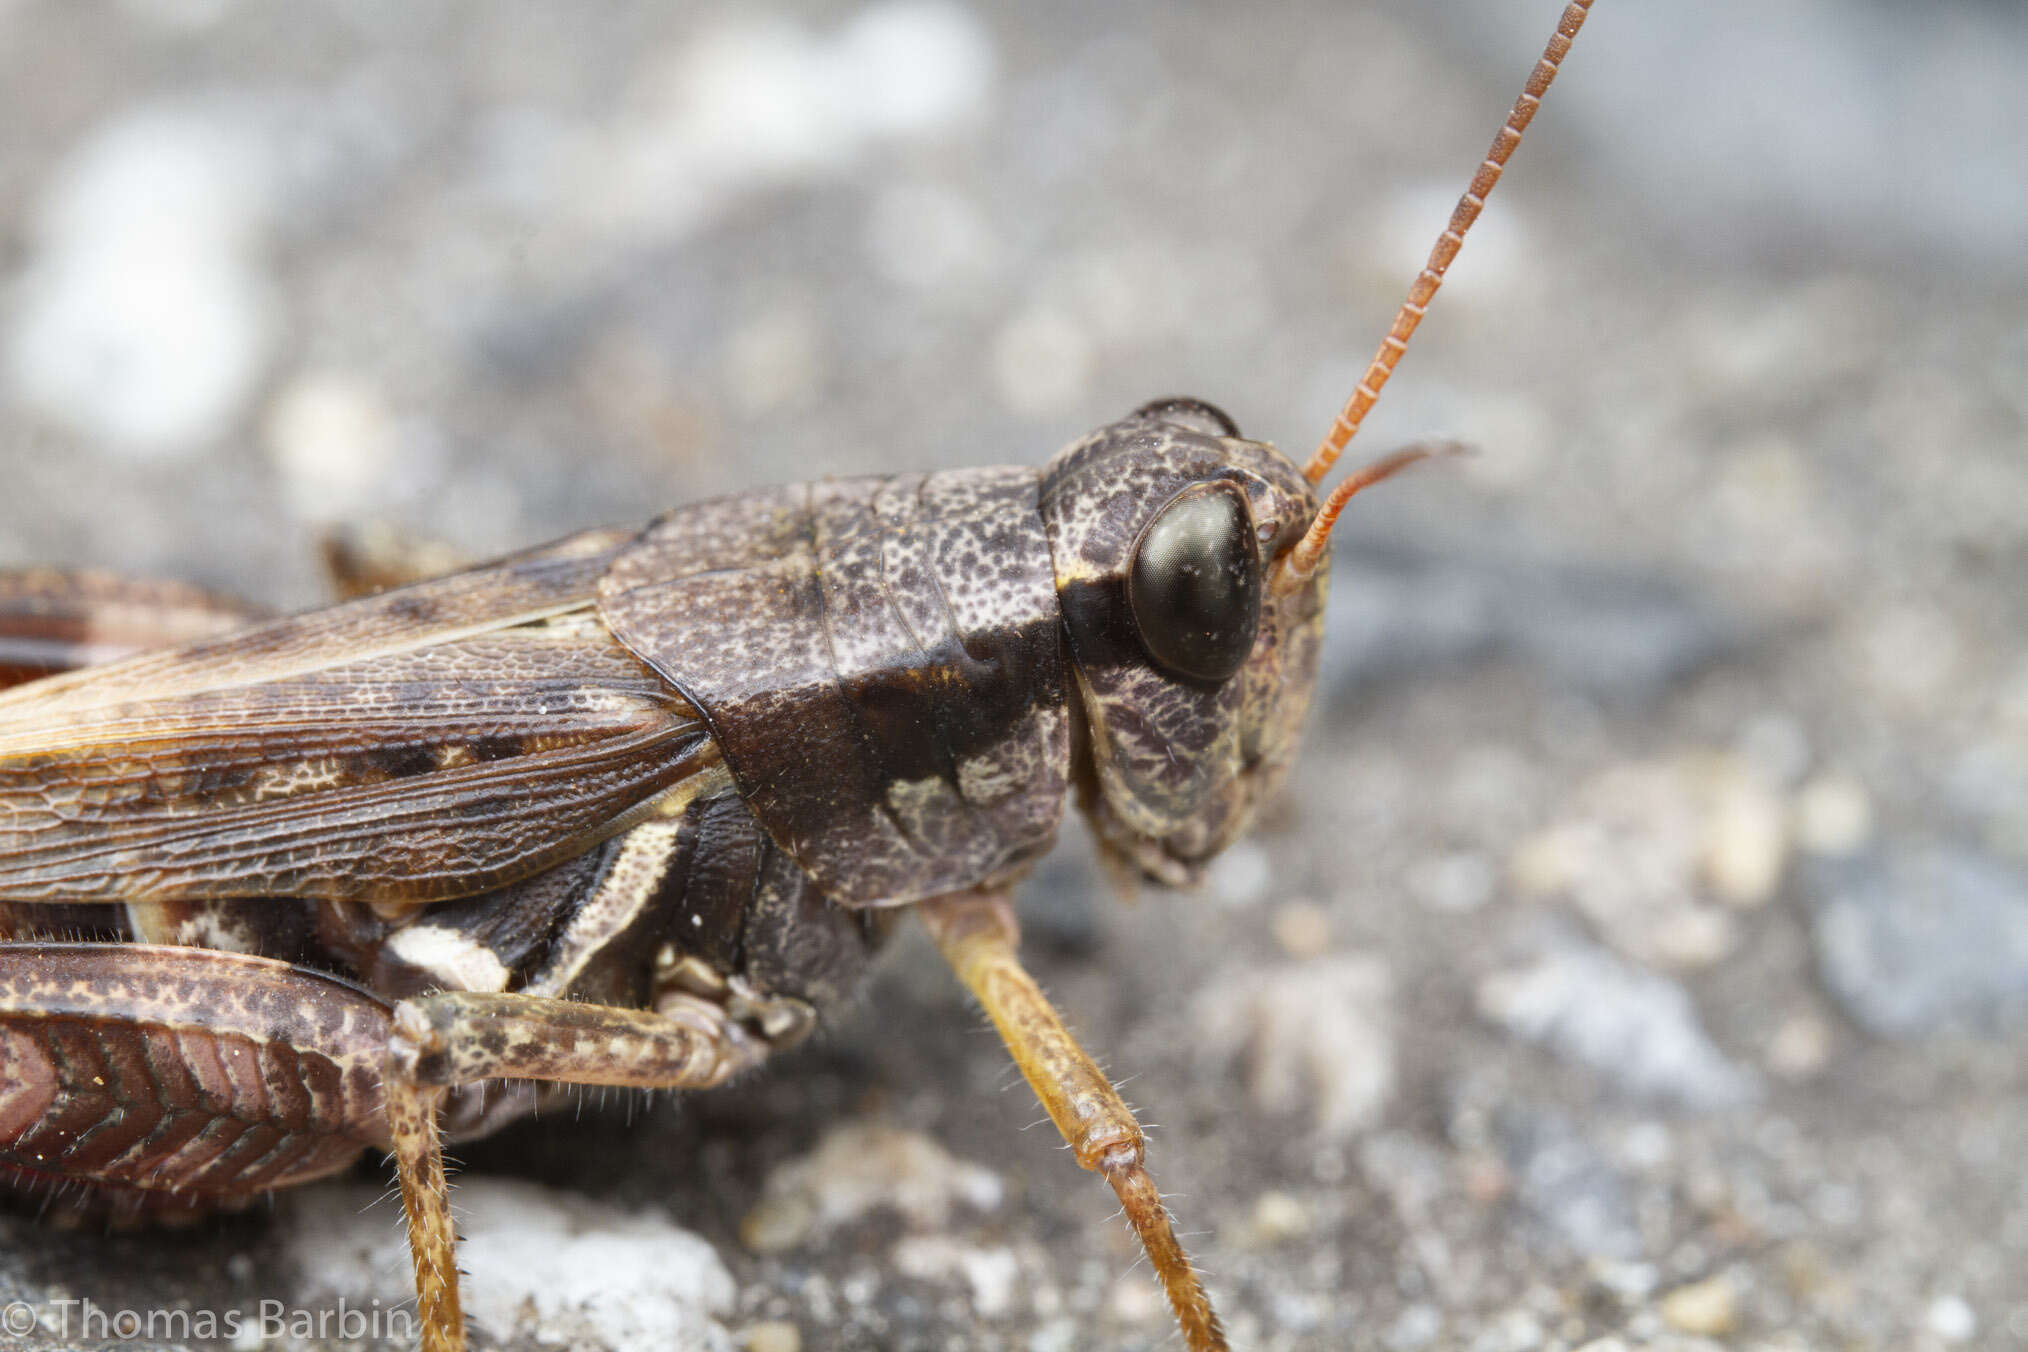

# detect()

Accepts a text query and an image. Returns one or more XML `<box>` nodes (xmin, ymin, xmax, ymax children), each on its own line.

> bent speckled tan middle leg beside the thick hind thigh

<box><xmin>381</xmin><ymin>991</ymin><xmax>767</xmax><ymax>1352</ymax></box>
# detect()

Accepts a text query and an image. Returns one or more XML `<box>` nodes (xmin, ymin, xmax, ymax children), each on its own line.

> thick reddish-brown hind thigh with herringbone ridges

<box><xmin>0</xmin><ymin>943</ymin><xmax>391</xmax><ymax>1222</ymax></box>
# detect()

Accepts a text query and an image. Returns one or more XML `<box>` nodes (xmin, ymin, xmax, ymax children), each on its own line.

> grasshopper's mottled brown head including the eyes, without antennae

<box><xmin>1042</xmin><ymin>399</ymin><xmax>1328</xmax><ymax>886</ymax></box>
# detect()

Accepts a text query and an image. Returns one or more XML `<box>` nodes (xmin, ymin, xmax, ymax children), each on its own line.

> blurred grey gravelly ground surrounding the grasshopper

<box><xmin>0</xmin><ymin>0</ymin><xmax>2028</xmax><ymax>1352</ymax></box>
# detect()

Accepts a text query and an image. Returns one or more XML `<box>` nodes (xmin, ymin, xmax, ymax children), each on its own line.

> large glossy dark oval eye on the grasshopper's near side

<box><xmin>1128</xmin><ymin>480</ymin><xmax>1261</xmax><ymax>681</ymax></box>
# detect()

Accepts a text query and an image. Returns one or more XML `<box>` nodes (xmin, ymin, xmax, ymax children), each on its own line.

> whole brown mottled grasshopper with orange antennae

<box><xmin>0</xmin><ymin>0</ymin><xmax>1590</xmax><ymax>1350</ymax></box>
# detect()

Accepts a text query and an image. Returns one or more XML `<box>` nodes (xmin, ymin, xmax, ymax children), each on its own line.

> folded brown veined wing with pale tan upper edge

<box><xmin>0</xmin><ymin>533</ymin><xmax>716</xmax><ymax>902</ymax></box>
